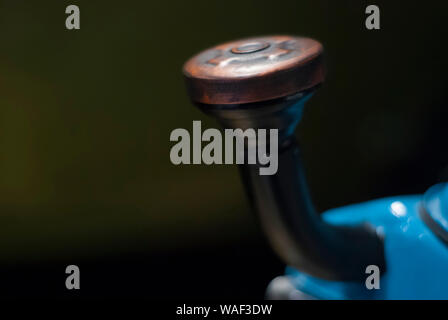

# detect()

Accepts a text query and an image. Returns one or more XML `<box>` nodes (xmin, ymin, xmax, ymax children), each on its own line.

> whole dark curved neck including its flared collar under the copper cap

<box><xmin>200</xmin><ymin>90</ymin><xmax>386</xmax><ymax>281</ymax></box>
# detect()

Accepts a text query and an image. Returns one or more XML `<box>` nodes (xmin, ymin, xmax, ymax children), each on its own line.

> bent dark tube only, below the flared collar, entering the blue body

<box><xmin>240</xmin><ymin>138</ymin><xmax>385</xmax><ymax>281</ymax></box>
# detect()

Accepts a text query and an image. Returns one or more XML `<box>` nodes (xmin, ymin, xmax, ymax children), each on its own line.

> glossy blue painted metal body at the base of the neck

<box><xmin>286</xmin><ymin>184</ymin><xmax>448</xmax><ymax>299</ymax></box>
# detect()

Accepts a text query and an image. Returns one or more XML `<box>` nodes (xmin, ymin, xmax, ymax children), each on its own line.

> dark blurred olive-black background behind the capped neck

<box><xmin>0</xmin><ymin>0</ymin><xmax>448</xmax><ymax>299</ymax></box>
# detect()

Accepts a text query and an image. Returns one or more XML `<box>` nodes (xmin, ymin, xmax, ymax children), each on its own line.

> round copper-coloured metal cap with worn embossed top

<box><xmin>183</xmin><ymin>36</ymin><xmax>324</xmax><ymax>104</ymax></box>
